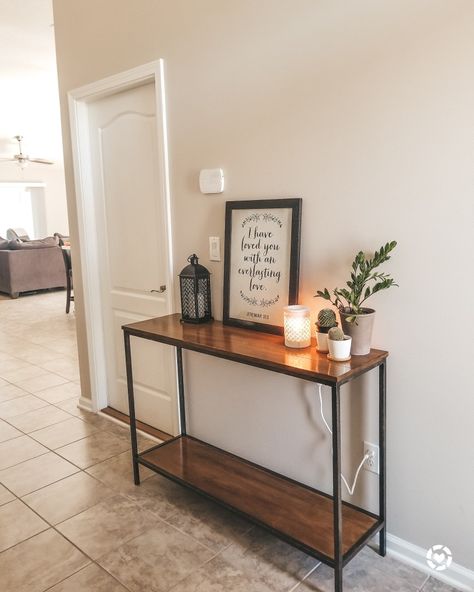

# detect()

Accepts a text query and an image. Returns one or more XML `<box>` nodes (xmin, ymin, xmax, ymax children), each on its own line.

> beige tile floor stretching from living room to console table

<box><xmin>0</xmin><ymin>292</ymin><xmax>460</xmax><ymax>592</ymax></box>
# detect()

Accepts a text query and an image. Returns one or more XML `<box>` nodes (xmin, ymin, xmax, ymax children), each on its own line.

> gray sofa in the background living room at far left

<box><xmin>0</xmin><ymin>237</ymin><xmax>66</xmax><ymax>298</ymax></box>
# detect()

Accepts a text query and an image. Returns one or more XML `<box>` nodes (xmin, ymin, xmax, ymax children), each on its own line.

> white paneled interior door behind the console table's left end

<box><xmin>88</xmin><ymin>82</ymin><xmax>177</xmax><ymax>434</ymax></box>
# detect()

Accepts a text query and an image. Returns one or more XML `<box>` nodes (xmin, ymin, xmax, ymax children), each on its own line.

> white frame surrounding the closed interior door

<box><xmin>68</xmin><ymin>59</ymin><xmax>174</xmax><ymax>411</ymax></box>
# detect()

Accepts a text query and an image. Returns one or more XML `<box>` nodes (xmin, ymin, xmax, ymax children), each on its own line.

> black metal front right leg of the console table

<box><xmin>332</xmin><ymin>386</ymin><xmax>342</xmax><ymax>592</ymax></box>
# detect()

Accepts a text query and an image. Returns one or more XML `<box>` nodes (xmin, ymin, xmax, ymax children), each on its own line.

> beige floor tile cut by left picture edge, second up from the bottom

<box><xmin>0</xmin><ymin>500</ymin><xmax>49</xmax><ymax>552</ymax></box>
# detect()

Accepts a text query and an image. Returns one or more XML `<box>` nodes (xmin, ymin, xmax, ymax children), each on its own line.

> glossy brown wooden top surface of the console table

<box><xmin>123</xmin><ymin>314</ymin><xmax>388</xmax><ymax>384</ymax></box>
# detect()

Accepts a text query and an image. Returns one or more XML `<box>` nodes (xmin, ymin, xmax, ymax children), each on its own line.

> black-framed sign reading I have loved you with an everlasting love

<box><xmin>223</xmin><ymin>199</ymin><xmax>302</xmax><ymax>335</ymax></box>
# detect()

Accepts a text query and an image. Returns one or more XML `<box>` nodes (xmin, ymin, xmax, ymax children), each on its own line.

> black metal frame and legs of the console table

<box><xmin>123</xmin><ymin>327</ymin><xmax>387</xmax><ymax>592</ymax></box>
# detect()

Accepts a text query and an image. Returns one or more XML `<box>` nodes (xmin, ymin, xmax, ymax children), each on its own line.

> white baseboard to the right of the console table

<box><xmin>387</xmin><ymin>534</ymin><xmax>474</xmax><ymax>592</ymax></box>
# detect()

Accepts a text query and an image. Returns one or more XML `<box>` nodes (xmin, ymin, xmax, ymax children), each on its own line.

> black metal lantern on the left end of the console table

<box><xmin>179</xmin><ymin>255</ymin><xmax>212</xmax><ymax>323</ymax></box>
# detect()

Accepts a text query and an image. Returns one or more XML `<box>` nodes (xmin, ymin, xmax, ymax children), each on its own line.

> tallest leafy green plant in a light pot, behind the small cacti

<box><xmin>316</xmin><ymin>241</ymin><xmax>398</xmax><ymax>356</ymax></box>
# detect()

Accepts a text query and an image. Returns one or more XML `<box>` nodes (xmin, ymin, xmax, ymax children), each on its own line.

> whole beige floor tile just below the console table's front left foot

<box><xmin>56</xmin><ymin>495</ymin><xmax>160</xmax><ymax>560</ymax></box>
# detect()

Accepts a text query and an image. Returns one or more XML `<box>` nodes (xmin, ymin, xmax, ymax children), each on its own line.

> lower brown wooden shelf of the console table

<box><xmin>139</xmin><ymin>436</ymin><xmax>382</xmax><ymax>565</ymax></box>
